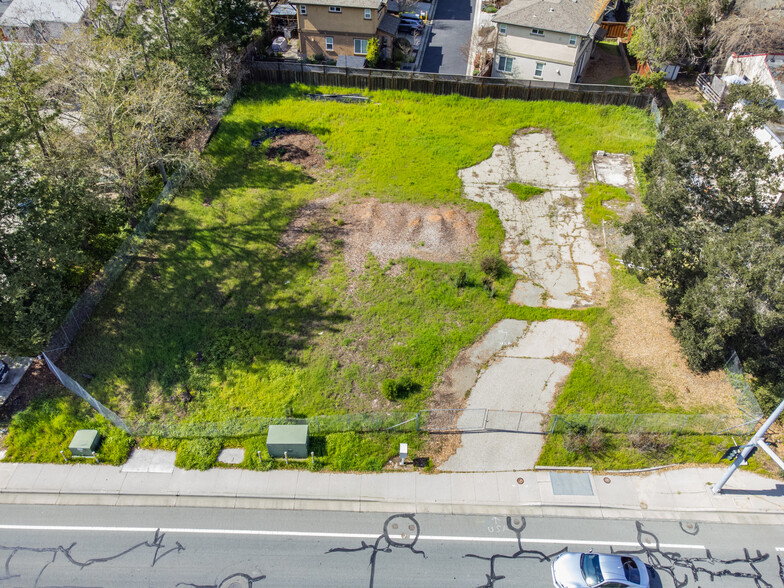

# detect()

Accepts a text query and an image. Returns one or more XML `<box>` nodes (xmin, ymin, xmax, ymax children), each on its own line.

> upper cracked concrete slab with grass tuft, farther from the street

<box><xmin>459</xmin><ymin>132</ymin><xmax>610</xmax><ymax>308</ymax></box>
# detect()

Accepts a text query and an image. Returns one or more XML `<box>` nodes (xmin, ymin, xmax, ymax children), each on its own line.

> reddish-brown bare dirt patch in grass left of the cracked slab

<box><xmin>340</xmin><ymin>200</ymin><xmax>477</xmax><ymax>272</ymax></box>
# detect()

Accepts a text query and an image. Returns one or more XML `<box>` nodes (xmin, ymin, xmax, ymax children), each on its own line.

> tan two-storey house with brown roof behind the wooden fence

<box><xmin>297</xmin><ymin>0</ymin><xmax>400</xmax><ymax>60</ymax></box>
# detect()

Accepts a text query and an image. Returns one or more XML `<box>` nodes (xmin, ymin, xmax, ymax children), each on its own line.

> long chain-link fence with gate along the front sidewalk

<box><xmin>131</xmin><ymin>409</ymin><xmax>759</xmax><ymax>439</ymax></box>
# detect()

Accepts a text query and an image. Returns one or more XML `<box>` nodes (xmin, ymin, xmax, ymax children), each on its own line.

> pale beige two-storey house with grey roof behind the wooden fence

<box><xmin>492</xmin><ymin>0</ymin><xmax>609</xmax><ymax>83</ymax></box>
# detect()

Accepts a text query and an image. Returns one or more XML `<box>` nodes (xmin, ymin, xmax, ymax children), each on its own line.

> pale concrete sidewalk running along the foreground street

<box><xmin>0</xmin><ymin>450</ymin><xmax>784</xmax><ymax>524</ymax></box>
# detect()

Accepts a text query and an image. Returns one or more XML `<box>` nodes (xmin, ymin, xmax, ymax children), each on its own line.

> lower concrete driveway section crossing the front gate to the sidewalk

<box><xmin>440</xmin><ymin>319</ymin><xmax>586</xmax><ymax>472</ymax></box>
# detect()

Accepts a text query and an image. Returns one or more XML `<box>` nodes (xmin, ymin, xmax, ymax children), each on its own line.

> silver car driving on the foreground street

<box><xmin>553</xmin><ymin>552</ymin><xmax>651</xmax><ymax>588</ymax></box>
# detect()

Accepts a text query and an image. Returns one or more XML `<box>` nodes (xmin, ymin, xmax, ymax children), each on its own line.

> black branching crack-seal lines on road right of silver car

<box><xmin>611</xmin><ymin>521</ymin><xmax>781</xmax><ymax>588</ymax></box>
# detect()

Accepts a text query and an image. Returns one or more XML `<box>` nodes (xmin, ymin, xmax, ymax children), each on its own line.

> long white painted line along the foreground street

<box><xmin>0</xmin><ymin>525</ymin><xmax>704</xmax><ymax>550</ymax></box>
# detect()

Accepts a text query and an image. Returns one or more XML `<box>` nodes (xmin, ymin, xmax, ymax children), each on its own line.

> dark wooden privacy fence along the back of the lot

<box><xmin>247</xmin><ymin>61</ymin><xmax>651</xmax><ymax>108</ymax></box>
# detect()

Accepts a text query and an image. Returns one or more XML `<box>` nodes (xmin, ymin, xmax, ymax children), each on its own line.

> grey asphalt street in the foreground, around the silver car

<box><xmin>0</xmin><ymin>505</ymin><xmax>784</xmax><ymax>588</ymax></box>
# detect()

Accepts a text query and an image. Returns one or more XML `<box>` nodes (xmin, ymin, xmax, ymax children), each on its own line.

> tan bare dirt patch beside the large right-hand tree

<box><xmin>612</xmin><ymin>291</ymin><xmax>738</xmax><ymax>414</ymax></box>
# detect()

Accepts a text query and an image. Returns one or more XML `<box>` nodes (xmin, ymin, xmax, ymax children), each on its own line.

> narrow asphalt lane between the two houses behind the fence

<box><xmin>419</xmin><ymin>0</ymin><xmax>477</xmax><ymax>76</ymax></box>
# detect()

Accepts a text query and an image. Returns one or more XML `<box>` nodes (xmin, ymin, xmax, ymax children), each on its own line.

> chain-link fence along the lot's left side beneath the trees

<box><xmin>44</xmin><ymin>81</ymin><xmax>242</xmax><ymax>362</ymax></box>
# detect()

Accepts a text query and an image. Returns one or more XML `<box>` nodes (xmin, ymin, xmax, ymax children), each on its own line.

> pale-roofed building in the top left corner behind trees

<box><xmin>0</xmin><ymin>0</ymin><xmax>90</xmax><ymax>42</ymax></box>
